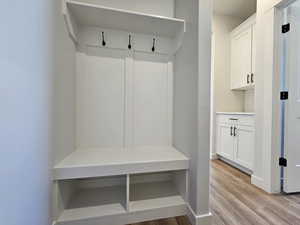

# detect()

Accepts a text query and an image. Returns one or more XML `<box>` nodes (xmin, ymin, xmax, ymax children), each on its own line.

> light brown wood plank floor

<box><xmin>129</xmin><ymin>160</ymin><xmax>300</xmax><ymax>225</ymax></box>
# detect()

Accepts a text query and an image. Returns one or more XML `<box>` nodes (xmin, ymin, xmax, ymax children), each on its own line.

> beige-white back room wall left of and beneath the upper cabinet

<box><xmin>213</xmin><ymin>14</ymin><xmax>244</xmax><ymax>112</ymax></box>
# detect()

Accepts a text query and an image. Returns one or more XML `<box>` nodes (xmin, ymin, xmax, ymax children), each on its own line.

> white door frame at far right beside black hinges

<box><xmin>261</xmin><ymin>0</ymin><xmax>297</xmax><ymax>193</ymax></box>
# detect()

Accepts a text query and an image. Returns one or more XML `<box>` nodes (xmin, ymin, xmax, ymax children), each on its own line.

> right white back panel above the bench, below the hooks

<box><xmin>133</xmin><ymin>53</ymin><xmax>173</xmax><ymax>146</ymax></box>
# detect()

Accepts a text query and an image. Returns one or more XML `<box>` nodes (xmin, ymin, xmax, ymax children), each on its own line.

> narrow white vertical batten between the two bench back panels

<box><xmin>124</xmin><ymin>57</ymin><xmax>133</xmax><ymax>148</ymax></box>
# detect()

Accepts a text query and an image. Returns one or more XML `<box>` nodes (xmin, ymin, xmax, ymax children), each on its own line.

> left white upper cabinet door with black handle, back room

<box><xmin>231</xmin><ymin>27</ymin><xmax>252</xmax><ymax>89</ymax></box>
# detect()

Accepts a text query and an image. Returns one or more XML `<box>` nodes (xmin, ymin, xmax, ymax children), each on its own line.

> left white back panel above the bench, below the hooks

<box><xmin>76</xmin><ymin>48</ymin><xmax>125</xmax><ymax>149</ymax></box>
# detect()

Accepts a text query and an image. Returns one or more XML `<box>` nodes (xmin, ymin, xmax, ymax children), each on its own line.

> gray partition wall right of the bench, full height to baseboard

<box><xmin>173</xmin><ymin>0</ymin><xmax>211</xmax><ymax>224</ymax></box>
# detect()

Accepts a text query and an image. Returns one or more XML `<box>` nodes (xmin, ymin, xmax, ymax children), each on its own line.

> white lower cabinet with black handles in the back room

<box><xmin>217</xmin><ymin>114</ymin><xmax>255</xmax><ymax>170</ymax></box>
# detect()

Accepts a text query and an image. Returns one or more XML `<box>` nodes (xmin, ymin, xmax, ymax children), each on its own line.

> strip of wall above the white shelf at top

<box><xmin>72</xmin><ymin>0</ymin><xmax>174</xmax><ymax>17</ymax></box>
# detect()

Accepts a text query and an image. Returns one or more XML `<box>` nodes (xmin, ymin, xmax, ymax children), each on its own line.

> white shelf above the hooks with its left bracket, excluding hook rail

<box><xmin>63</xmin><ymin>0</ymin><xmax>185</xmax><ymax>49</ymax></box>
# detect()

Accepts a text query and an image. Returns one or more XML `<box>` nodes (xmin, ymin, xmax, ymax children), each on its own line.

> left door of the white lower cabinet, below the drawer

<box><xmin>217</xmin><ymin>124</ymin><xmax>234</xmax><ymax>160</ymax></box>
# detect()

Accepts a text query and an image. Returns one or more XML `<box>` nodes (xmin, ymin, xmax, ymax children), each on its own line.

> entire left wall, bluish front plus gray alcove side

<box><xmin>0</xmin><ymin>0</ymin><xmax>75</xmax><ymax>225</ymax></box>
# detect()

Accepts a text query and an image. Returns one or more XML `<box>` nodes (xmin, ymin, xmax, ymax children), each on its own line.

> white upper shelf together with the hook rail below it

<box><xmin>63</xmin><ymin>0</ymin><xmax>185</xmax><ymax>55</ymax></box>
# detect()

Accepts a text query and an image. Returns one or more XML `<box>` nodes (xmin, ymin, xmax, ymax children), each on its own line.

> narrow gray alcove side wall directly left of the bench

<box><xmin>52</xmin><ymin>0</ymin><xmax>76</xmax><ymax>163</ymax></box>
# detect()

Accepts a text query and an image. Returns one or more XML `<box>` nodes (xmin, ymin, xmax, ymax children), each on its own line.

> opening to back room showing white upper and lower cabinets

<box><xmin>211</xmin><ymin>0</ymin><xmax>256</xmax><ymax>175</ymax></box>
